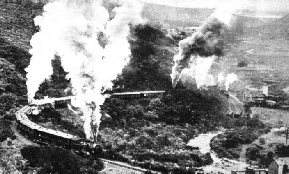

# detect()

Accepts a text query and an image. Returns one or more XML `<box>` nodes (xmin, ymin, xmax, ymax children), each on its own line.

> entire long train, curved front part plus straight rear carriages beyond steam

<box><xmin>15</xmin><ymin>88</ymin><xmax>238</xmax><ymax>158</ymax></box>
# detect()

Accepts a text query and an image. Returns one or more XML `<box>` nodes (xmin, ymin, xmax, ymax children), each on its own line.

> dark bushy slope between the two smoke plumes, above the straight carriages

<box><xmin>114</xmin><ymin>25</ymin><xmax>173</xmax><ymax>91</ymax></box>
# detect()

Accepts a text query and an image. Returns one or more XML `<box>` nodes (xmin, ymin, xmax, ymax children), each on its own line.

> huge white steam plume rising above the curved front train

<box><xmin>26</xmin><ymin>0</ymin><xmax>144</xmax><ymax>139</ymax></box>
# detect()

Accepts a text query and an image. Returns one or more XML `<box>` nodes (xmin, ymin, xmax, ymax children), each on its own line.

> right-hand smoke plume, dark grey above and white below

<box><xmin>171</xmin><ymin>9</ymin><xmax>236</xmax><ymax>88</ymax></box>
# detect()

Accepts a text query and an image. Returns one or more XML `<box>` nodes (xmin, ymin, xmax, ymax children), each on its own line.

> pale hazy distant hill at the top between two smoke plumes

<box><xmin>143</xmin><ymin>3</ymin><xmax>213</xmax><ymax>28</ymax></box>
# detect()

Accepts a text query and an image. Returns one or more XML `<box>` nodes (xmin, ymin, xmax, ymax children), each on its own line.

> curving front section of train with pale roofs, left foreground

<box><xmin>15</xmin><ymin>98</ymin><xmax>102</xmax><ymax>155</ymax></box>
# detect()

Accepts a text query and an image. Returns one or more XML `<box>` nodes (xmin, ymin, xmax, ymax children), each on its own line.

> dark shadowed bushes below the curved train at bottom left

<box><xmin>21</xmin><ymin>146</ymin><xmax>103</xmax><ymax>174</ymax></box>
